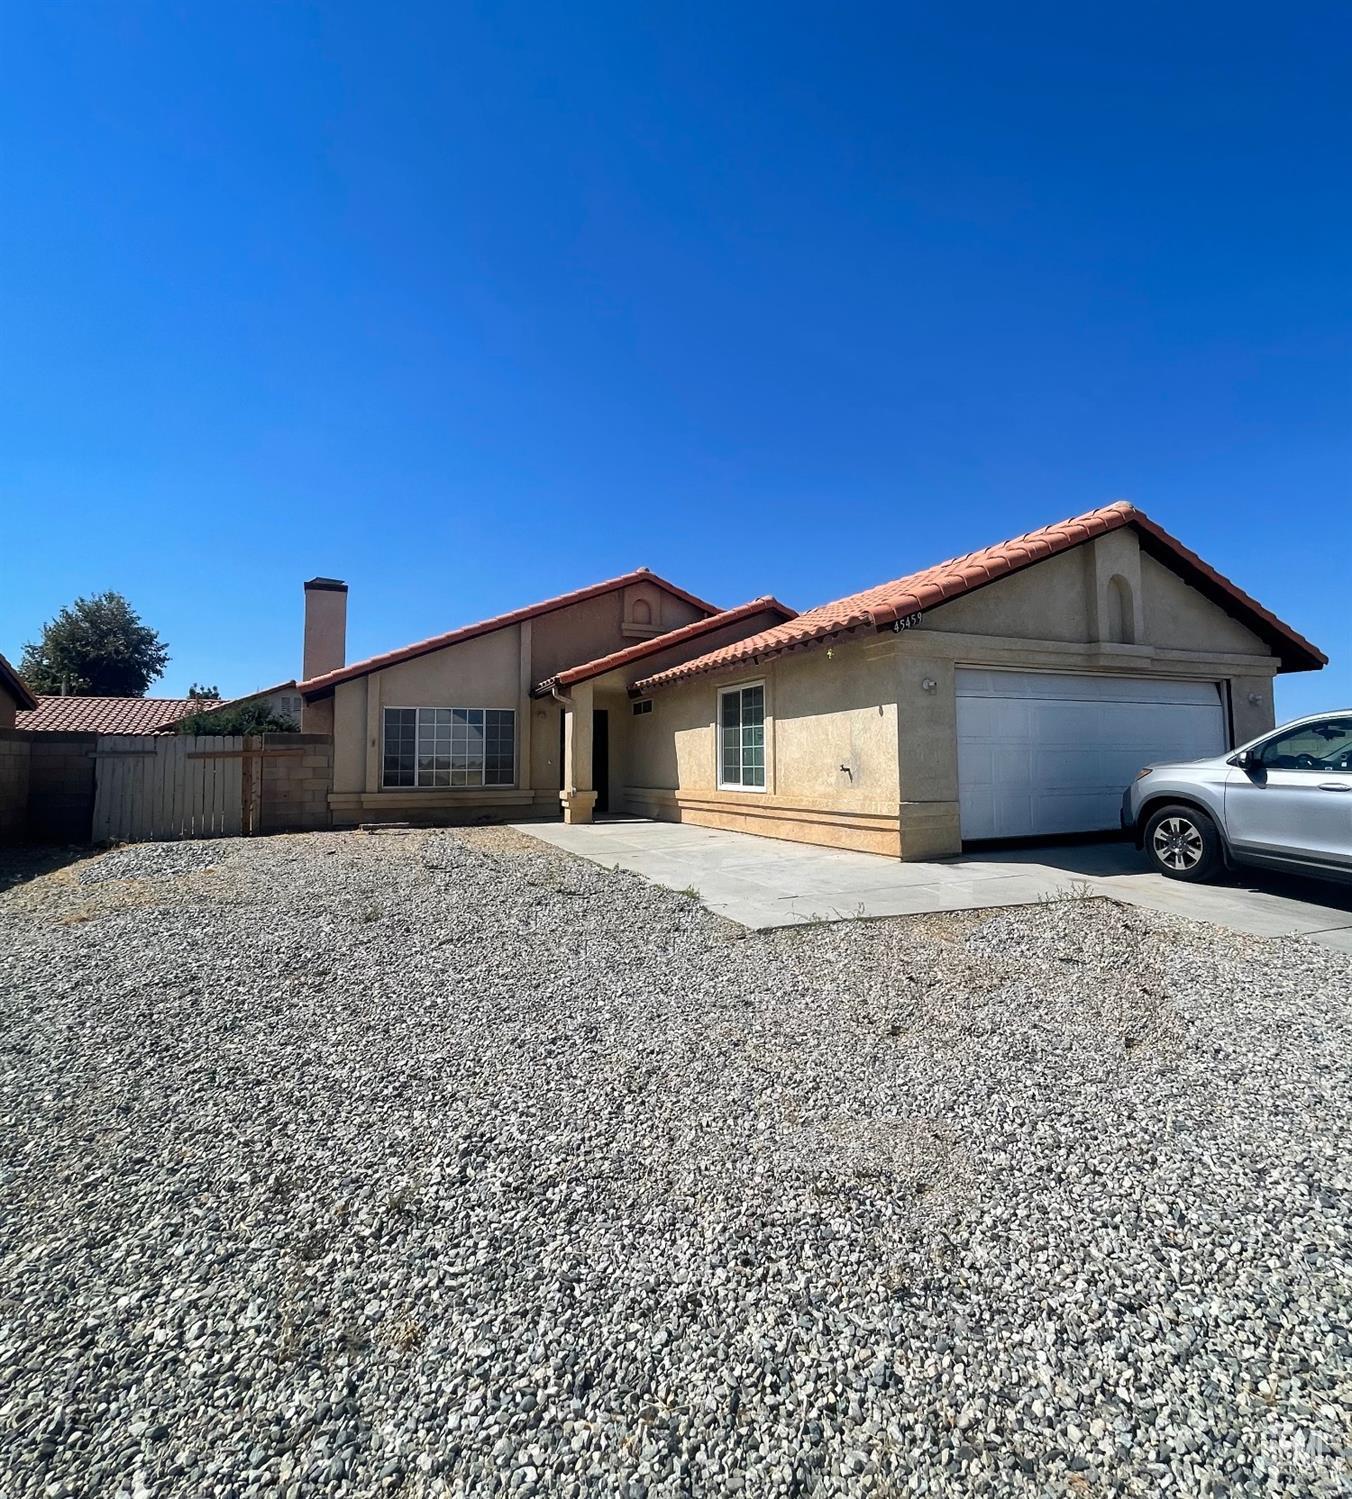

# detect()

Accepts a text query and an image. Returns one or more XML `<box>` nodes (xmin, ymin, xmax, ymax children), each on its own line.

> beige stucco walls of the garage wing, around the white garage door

<box><xmin>641</xmin><ymin>529</ymin><xmax>1279</xmax><ymax>859</ymax></box>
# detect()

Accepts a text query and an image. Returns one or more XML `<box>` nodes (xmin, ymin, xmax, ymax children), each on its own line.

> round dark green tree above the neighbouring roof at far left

<box><xmin>19</xmin><ymin>592</ymin><xmax>169</xmax><ymax>697</ymax></box>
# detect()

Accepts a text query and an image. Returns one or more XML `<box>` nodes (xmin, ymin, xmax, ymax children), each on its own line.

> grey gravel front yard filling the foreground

<box><xmin>0</xmin><ymin>830</ymin><xmax>1352</xmax><ymax>1499</ymax></box>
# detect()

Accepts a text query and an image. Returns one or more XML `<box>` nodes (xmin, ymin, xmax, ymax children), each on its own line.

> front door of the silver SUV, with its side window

<box><xmin>1225</xmin><ymin>715</ymin><xmax>1352</xmax><ymax>871</ymax></box>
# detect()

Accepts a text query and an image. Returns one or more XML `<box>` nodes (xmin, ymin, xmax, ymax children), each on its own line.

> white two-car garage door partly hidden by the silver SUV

<box><xmin>958</xmin><ymin>670</ymin><xmax>1226</xmax><ymax>838</ymax></box>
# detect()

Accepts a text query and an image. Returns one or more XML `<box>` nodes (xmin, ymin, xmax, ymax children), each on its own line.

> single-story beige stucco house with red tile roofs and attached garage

<box><xmin>298</xmin><ymin>502</ymin><xmax>1325</xmax><ymax>859</ymax></box>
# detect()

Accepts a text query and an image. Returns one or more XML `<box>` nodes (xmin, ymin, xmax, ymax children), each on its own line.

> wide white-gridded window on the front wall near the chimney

<box><xmin>382</xmin><ymin>708</ymin><xmax>516</xmax><ymax>787</ymax></box>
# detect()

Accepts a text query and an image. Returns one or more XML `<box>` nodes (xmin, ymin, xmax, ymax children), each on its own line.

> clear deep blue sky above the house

<box><xmin>0</xmin><ymin>0</ymin><xmax>1352</xmax><ymax>714</ymax></box>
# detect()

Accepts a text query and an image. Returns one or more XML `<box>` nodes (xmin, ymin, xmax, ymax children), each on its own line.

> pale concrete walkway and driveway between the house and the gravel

<box><xmin>516</xmin><ymin>818</ymin><xmax>1352</xmax><ymax>952</ymax></box>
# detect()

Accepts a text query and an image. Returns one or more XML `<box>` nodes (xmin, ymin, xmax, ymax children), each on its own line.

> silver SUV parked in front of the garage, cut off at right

<box><xmin>1123</xmin><ymin>709</ymin><xmax>1352</xmax><ymax>880</ymax></box>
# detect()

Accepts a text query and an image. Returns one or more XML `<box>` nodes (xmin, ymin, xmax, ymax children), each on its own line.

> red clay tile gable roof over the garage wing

<box><xmin>634</xmin><ymin>501</ymin><xmax>1328</xmax><ymax>691</ymax></box>
